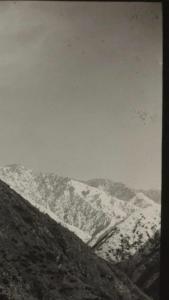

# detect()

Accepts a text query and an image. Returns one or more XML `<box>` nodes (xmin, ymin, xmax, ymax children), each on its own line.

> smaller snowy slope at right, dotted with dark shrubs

<box><xmin>92</xmin><ymin>200</ymin><xmax>161</xmax><ymax>262</ymax></box>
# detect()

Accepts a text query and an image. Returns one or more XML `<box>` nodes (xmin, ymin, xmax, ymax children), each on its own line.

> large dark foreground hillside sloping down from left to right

<box><xmin>0</xmin><ymin>181</ymin><xmax>150</xmax><ymax>300</ymax></box>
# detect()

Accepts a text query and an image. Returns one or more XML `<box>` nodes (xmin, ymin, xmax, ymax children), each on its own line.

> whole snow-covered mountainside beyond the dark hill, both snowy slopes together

<box><xmin>0</xmin><ymin>165</ymin><xmax>160</xmax><ymax>270</ymax></box>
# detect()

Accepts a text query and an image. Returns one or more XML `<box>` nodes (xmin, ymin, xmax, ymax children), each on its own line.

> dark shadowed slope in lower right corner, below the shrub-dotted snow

<box><xmin>119</xmin><ymin>231</ymin><xmax>160</xmax><ymax>300</ymax></box>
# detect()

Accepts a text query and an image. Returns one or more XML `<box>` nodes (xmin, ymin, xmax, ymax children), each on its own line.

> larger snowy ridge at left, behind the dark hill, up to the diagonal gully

<box><xmin>0</xmin><ymin>165</ymin><xmax>136</xmax><ymax>242</ymax></box>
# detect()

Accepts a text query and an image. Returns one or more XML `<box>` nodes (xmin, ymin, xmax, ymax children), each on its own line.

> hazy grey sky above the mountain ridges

<box><xmin>0</xmin><ymin>1</ymin><xmax>162</xmax><ymax>188</ymax></box>
